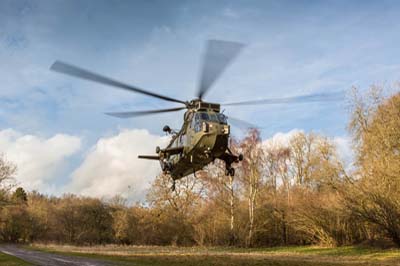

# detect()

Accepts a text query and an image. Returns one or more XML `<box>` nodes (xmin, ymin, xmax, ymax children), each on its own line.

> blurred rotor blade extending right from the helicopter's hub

<box><xmin>221</xmin><ymin>92</ymin><xmax>345</xmax><ymax>106</ymax></box>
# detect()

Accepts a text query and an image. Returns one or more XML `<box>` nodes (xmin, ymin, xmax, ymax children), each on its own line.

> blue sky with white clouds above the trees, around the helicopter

<box><xmin>0</xmin><ymin>0</ymin><xmax>400</xmax><ymax>200</ymax></box>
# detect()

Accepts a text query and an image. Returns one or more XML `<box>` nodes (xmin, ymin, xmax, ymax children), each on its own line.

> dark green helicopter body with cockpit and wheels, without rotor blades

<box><xmin>140</xmin><ymin>100</ymin><xmax>239</xmax><ymax>180</ymax></box>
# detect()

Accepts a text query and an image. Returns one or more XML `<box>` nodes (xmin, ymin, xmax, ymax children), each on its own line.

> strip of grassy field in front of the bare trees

<box><xmin>30</xmin><ymin>244</ymin><xmax>400</xmax><ymax>266</ymax></box>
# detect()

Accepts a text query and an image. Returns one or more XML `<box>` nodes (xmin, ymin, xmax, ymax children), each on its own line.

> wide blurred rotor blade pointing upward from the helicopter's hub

<box><xmin>197</xmin><ymin>40</ymin><xmax>244</xmax><ymax>99</ymax></box>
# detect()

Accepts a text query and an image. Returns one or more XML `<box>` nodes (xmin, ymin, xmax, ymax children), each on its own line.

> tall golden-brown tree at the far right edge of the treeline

<box><xmin>344</xmin><ymin>87</ymin><xmax>400</xmax><ymax>245</ymax></box>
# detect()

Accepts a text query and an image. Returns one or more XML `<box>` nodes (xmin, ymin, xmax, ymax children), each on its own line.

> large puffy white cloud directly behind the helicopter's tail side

<box><xmin>65</xmin><ymin>129</ymin><xmax>168</xmax><ymax>200</ymax></box>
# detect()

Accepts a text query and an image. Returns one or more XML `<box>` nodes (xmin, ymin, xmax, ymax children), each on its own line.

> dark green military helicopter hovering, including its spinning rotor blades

<box><xmin>50</xmin><ymin>40</ymin><xmax>343</xmax><ymax>189</ymax></box>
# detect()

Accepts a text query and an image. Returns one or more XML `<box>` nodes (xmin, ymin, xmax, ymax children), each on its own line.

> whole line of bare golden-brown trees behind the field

<box><xmin>0</xmin><ymin>89</ymin><xmax>400</xmax><ymax>247</ymax></box>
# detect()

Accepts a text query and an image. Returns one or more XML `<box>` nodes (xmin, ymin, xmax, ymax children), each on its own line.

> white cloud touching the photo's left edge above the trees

<box><xmin>0</xmin><ymin>129</ymin><xmax>81</xmax><ymax>192</ymax></box>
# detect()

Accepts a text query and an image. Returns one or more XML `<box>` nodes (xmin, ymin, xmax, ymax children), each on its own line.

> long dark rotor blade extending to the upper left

<box><xmin>50</xmin><ymin>61</ymin><xmax>186</xmax><ymax>104</ymax></box>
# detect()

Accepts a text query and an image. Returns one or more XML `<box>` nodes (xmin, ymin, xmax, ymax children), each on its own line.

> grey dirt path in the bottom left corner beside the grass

<box><xmin>0</xmin><ymin>245</ymin><xmax>116</xmax><ymax>266</ymax></box>
